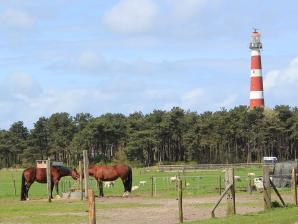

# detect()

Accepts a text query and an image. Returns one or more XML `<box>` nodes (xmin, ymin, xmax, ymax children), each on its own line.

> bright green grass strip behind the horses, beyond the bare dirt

<box><xmin>0</xmin><ymin>167</ymin><xmax>261</xmax><ymax>200</ymax></box>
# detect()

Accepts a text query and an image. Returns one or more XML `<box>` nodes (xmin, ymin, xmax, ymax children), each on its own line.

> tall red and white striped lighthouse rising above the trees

<box><xmin>249</xmin><ymin>29</ymin><xmax>264</xmax><ymax>109</ymax></box>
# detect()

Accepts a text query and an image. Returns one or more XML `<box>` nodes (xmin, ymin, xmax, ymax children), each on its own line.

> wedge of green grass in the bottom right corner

<box><xmin>187</xmin><ymin>207</ymin><xmax>298</xmax><ymax>224</ymax></box>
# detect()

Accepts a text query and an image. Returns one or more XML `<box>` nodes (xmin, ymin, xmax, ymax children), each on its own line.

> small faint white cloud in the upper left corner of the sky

<box><xmin>0</xmin><ymin>9</ymin><xmax>34</xmax><ymax>29</ymax></box>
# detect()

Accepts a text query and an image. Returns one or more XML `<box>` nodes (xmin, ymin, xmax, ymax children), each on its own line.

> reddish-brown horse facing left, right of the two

<box><xmin>88</xmin><ymin>165</ymin><xmax>132</xmax><ymax>197</ymax></box>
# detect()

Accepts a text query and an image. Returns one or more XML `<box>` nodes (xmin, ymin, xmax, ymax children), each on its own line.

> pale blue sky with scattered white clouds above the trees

<box><xmin>0</xmin><ymin>0</ymin><xmax>298</xmax><ymax>129</ymax></box>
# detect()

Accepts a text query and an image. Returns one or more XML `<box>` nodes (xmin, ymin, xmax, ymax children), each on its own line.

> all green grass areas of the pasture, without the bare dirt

<box><xmin>0</xmin><ymin>167</ymin><xmax>298</xmax><ymax>224</ymax></box>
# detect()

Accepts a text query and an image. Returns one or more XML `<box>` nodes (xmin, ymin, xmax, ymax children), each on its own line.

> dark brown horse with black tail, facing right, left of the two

<box><xmin>21</xmin><ymin>166</ymin><xmax>80</xmax><ymax>201</ymax></box>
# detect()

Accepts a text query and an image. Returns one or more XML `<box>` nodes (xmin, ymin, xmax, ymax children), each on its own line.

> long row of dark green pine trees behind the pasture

<box><xmin>0</xmin><ymin>105</ymin><xmax>298</xmax><ymax>168</ymax></box>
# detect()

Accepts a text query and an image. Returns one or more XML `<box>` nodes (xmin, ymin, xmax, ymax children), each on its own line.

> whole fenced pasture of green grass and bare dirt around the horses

<box><xmin>0</xmin><ymin>167</ymin><xmax>298</xmax><ymax>224</ymax></box>
